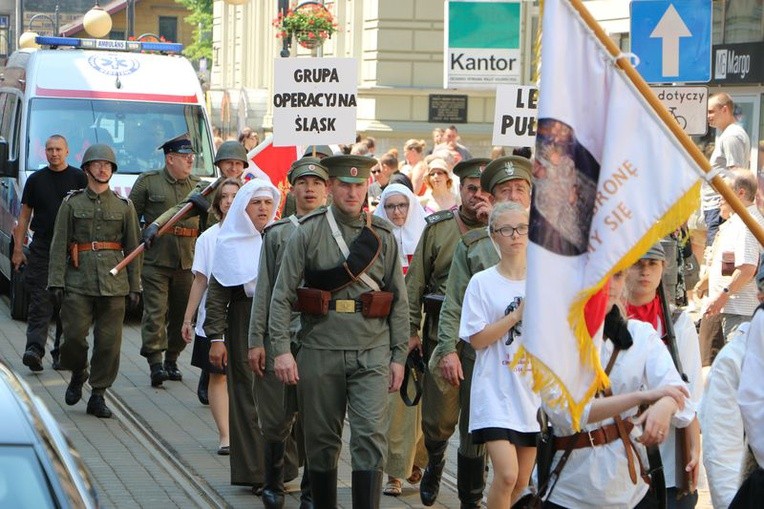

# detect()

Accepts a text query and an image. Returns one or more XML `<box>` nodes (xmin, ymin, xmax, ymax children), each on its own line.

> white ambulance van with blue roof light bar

<box><xmin>0</xmin><ymin>37</ymin><xmax>215</xmax><ymax>319</ymax></box>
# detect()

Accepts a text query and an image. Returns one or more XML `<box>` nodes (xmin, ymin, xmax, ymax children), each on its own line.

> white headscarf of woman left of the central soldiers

<box><xmin>212</xmin><ymin>178</ymin><xmax>281</xmax><ymax>297</ymax></box>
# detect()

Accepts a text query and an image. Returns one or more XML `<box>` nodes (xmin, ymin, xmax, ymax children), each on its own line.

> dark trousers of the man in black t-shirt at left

<box><xmin>24</xmin><ymin>242</ymin><xmax>58</xmax><ymax>356</ymax></box>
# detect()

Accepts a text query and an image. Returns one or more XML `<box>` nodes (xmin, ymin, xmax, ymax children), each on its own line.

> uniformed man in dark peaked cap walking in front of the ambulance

<box><xmin>130</xmin><ymin>133</ymin><xmax>206</xmax><ymax>387</ymax></box>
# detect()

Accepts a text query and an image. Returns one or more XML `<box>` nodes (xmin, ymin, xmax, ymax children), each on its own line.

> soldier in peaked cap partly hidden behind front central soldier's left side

<box><xmin>249</xmin><ymin>157</ymin><xmax>329</xmax><ymax>508</ymax></box>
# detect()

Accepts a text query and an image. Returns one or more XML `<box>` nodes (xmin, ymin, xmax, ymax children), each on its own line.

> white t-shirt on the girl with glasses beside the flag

<box><xmin>459</xmin><ymin>266</ymin><xmax>541</xmax><ymax>433</ymax></box>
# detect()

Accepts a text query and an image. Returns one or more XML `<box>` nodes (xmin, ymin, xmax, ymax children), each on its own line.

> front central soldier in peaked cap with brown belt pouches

<box><xmin>269</xmin><ymin>156</ymin><xmax>408</xmax><ymax>507</ymax></box>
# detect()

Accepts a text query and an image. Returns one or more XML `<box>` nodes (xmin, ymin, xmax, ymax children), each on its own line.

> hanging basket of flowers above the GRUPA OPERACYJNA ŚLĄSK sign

<box><xmin>273</xmin><ymin>2</ymin><xmax>337</xmax><ymax>49</ymax></box>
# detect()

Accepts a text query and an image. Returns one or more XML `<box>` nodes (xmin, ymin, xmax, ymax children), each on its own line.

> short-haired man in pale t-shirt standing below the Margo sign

<box><xmin>700</xmin><ymin>93</ymin><xmax>751</xmax><ymax>246</ymax></box>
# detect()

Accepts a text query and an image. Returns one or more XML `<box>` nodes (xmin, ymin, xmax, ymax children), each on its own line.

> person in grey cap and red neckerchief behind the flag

<box><xmin>626</xmin><ymin>240</ymin><xmax>703</xmax><ymax>508</ymax></box>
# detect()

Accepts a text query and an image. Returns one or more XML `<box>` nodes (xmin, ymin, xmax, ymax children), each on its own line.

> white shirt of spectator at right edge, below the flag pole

<box><xmin>708</xmin><ymin>205</ymin><xmax>764</xmax><ymax>316</ymax></box>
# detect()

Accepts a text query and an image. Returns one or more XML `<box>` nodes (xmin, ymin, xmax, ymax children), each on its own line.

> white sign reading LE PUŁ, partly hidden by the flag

<box><xmin>493</xmin><ymin>85</ymin><xmax>539</xmax><ymax>147</ymax></box>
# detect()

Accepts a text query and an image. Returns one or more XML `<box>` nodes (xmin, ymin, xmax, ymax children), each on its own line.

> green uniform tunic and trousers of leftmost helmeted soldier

<box><xmin>48</xmin><ymin>188</ymin><xmax>141</xmax><ymax>388</ymax></box>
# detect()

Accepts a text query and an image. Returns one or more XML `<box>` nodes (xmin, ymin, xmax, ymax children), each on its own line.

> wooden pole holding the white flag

<box><xmin>568</xmin><ymin>0</ymin><xmax>764</xmax><ymax>246</ymax></box>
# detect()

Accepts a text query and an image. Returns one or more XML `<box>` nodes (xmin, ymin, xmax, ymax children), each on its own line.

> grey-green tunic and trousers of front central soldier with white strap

<box><xmin>269</xmin><ymin>207</ymin><xmax>408</xmax><ymax>472</ymax></box>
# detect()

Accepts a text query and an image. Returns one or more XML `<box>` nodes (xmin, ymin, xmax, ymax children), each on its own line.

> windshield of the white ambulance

<box><xmin>27</xmin><ymin>98</ymin><xmax>214</xmax><ymax>177</ymax></box>
